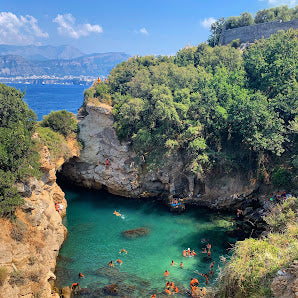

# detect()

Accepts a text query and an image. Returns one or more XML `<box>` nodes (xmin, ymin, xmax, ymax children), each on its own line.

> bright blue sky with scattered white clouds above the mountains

<box><xmin>0</xmin><ymin>0</ymin><xmax>298</xmax><ymax>55</ymax></box>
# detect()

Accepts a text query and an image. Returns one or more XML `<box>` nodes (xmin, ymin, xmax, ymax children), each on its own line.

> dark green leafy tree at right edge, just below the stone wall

<box><xmin>244</xmin><ymin>30</ymin><xmax>298</xmax><ymax>121</ymax></box>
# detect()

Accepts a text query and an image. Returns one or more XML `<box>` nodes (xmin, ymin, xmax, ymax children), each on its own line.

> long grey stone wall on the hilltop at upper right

<box><xmin>219</xmin><ymin>19</ymin><xmax>298</xmax><ymax>45</ymax></box>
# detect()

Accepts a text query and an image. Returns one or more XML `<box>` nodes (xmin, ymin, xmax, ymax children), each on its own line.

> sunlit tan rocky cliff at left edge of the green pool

<box><xmin>0</xmin><ymin>140</ymin><xmax>79</xmax><ymax>298</ymax></box>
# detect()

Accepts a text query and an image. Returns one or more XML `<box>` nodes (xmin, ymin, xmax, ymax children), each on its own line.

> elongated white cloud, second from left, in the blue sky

<box><xmin>53</xmin><ymin>13</ymin><xmax>103</xmax><ymax>39</ymax></box>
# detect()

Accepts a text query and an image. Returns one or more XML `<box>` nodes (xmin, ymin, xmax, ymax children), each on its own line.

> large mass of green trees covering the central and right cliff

<box><xmin>86</xmin><ymin>30</ymin><xmax>298</xmax><ymax>186</ymax></box>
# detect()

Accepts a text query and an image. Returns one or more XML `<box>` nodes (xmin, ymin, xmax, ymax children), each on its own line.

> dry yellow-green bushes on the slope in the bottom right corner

<box><xmin>218</xmin><ymin>197</ymin><xmax>298</xmax><ymax>298</ymax></box>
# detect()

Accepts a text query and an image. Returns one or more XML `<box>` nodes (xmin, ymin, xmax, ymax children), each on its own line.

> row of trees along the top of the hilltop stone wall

<box><xmin>208</xmin><ymin>5</ymin><xmax>298</xmax><ymax>46</ymax></box>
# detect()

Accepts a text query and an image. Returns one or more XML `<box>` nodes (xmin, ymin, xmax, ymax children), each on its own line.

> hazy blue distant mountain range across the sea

<box><xmin>0</xmin><ymin>45</ymin><xmax>129</xmax><ymax>77</ymax></box>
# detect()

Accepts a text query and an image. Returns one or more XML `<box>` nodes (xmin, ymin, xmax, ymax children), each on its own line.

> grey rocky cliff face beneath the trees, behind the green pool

<box><xmin>62</xmin><ymin>102</ymin><xmax>257</xmax><ymax>209</ymax></box>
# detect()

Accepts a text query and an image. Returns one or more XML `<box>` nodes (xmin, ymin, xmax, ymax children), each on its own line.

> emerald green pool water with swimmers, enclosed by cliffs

<box><xmin>56</xmin><ymin>187</ymin><xmax>235</xmax><ymax>297</ymax></box>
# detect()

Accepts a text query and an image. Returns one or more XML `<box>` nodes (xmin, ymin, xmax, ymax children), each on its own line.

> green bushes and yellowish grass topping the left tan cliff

<box><xmin>0</xmin><ymin>84</ymin><xmax>77</xmax><ymax>217</ymax></box>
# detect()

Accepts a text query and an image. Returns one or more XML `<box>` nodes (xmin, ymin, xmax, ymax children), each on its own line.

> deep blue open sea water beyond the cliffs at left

<box><xmin>7</xmin><ymin>83</ymin><xmax>89</xmax><ymax>120</ymax></box>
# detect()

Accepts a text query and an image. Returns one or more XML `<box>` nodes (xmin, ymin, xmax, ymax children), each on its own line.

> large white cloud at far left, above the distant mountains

<box><xmin>0</xmin><ymin>12</ymin><xmax>49</xmax><ymax>45</ymax></box>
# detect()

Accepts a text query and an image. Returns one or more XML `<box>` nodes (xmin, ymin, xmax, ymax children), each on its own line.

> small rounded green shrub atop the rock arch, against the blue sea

<box><xmin>40</xmin><ymin>110</ymin><xmax>78</xmax><ymax>137</ymax></box>
